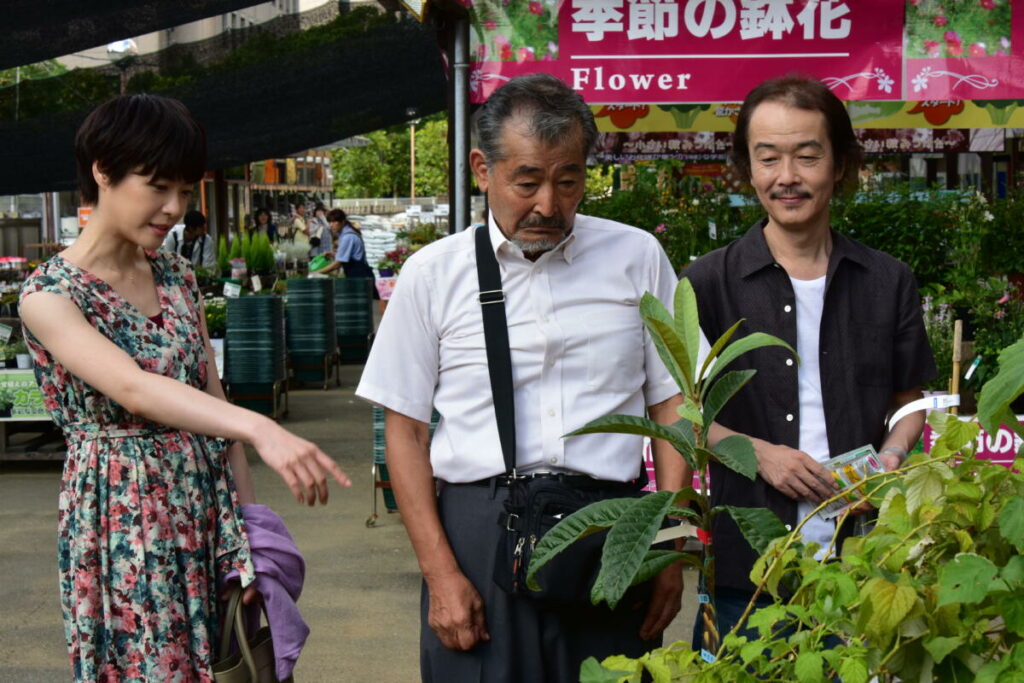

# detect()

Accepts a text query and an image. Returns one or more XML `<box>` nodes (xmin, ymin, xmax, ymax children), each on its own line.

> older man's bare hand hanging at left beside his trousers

<box><xmin>427</xmin><ymin>571</ymin><xmax>490</xmax><ymax>650</ymax></box>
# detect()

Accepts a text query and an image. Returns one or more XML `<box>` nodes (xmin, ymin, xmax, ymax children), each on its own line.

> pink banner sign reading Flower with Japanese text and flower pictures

<box><xmin>462</xmin><ymin>0</ymin><xmax>1024</xmax><ymax>131</ymax></box>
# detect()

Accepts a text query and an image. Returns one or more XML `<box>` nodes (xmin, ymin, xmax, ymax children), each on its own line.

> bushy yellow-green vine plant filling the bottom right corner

<box><xmin>582</xmin><ymin>329</ymin><xmax>1024</xmax><ymax>683</ymax></box>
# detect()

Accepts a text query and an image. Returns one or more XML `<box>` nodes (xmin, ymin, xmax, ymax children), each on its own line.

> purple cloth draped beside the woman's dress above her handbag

<box><xmin>223</xmin><ymin>505</ymin><xmax>309</xmax><ymax>680</ymax></box>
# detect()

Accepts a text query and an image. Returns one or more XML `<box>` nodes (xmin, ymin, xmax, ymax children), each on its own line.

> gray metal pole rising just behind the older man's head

<box><xmin>450</xmin><ymin>13</ymin><xmax>473</xmax><ymax>232</ymax></box>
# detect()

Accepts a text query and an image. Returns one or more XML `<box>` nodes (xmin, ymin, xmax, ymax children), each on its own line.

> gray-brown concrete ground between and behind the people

<box><xmin>0</xmin><ymin>366</ymin><xmax>695</xmax><ymax>683</ymax></box>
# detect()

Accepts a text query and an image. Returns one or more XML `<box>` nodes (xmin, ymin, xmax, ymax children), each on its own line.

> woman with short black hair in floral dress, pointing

<box><xmin>20</xmin><ymin>95</ymin><xmax>348</xmax><ymax>681</ymax></box>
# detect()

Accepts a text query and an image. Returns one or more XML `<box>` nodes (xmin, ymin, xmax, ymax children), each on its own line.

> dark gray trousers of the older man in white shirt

<box><xmin>420</xmin><ymin>484</ymin><xmax>662</xmax><ymax>683</ymax></box>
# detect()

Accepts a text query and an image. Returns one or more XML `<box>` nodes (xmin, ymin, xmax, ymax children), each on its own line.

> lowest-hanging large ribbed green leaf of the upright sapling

<box><xmin>598</xmin><ymin>490</ymin><xmax>676</xmax><ymax>609</ymax></box>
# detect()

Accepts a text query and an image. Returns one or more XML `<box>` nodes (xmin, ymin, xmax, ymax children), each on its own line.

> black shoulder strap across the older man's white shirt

<box><xmin>474</xmin><ymin>225</ymin><xmax>515</xmax><ymax>476</ymax></box>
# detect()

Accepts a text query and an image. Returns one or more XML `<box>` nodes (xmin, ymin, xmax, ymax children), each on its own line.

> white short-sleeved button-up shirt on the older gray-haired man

<box><xmin>356</xmin><ymin>215</ymin><xmax>679</xmax><ymax>482</ymax></box>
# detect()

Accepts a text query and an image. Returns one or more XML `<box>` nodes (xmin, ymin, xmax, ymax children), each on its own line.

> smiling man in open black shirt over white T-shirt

<box><xmin>683</xmin><ymin>77</ymin><xmax>935</xmax><ymax>647</ymax></box>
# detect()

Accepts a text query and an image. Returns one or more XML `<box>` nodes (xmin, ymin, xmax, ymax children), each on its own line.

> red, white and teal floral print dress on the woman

<box><xmin>22</xmin><ymin>251</ymin><xmax>253</xmax><ymax>682</ymax></box>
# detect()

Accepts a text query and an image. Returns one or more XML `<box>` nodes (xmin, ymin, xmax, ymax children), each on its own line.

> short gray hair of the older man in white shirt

<box><xmin>476</xmin><ymin>74</ymin><xmax>597</xmax><ymax>165</ymax></box>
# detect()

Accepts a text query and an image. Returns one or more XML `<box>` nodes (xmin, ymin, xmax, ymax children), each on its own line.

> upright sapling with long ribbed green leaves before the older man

<box><xmin>527</xmin><ymin>279</ymin><xmax>796</xmax><ymax>649</ymax></box>
